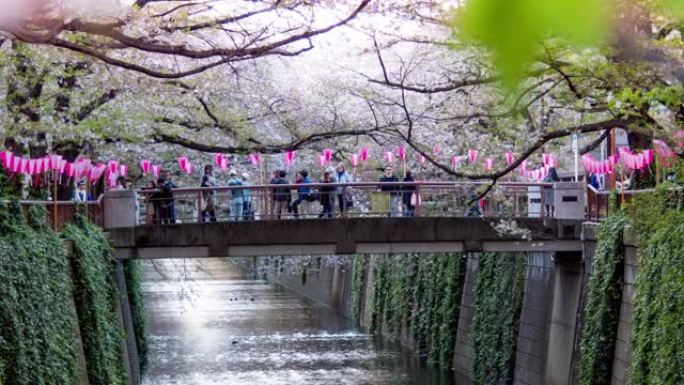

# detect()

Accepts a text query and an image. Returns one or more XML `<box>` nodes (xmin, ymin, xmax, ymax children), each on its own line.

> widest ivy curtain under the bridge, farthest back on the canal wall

<box><xmin>352</xmin><ymin>254</ymin><xmax>463</xmax><ymax>367</ymax></box>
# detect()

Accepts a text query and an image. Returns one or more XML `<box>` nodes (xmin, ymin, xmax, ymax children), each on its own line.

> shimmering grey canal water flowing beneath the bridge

<box><xmin>143</xmin><ymin>259</ymin><xmax>452</xmax><ymax>385</ymax></box>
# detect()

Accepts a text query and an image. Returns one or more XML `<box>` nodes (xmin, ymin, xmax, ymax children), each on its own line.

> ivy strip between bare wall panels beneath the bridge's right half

<box><xmin>470</xmin><ymin>253</ymin><xmax>527</xmax><ymax>385</ymax></box>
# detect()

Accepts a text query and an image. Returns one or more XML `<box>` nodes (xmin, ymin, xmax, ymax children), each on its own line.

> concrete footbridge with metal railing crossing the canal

<box><xmin>81</xmin><ymin>182</ymin><xmax>586</xmax><ymax>260</ymax></box>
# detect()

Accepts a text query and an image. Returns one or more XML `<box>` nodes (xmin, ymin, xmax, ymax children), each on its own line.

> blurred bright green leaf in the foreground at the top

<box><xmin>454</xmin><ymin>0</ymin><xmax>612</xmax><ymax>86</ymax></box>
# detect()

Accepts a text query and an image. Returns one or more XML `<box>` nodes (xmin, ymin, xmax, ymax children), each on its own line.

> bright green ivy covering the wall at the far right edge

<box><xmin>629</xmin><ymin>186</ymin><xmax>684</xmax><ymax>385</ymax></box>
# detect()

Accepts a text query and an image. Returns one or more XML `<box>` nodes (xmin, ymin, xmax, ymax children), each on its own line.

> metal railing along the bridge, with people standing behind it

<box><xmin>137</xmin><ymin>182</ymin><xmax>552</xmax><ymax>224</ymax></box>
